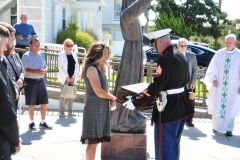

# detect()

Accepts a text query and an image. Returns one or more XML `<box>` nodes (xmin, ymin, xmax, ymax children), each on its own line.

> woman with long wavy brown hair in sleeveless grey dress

<box><xmin>80</xmin><ymin>42</ymin><xmax>116</xmax><ymax>160</ymax></box>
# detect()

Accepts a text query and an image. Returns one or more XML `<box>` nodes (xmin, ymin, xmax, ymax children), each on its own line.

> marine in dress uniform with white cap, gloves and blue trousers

<box><xmin>123</xmin><ymin>29</ymin><xmax>194</xmax><ymax>160</ymax></box>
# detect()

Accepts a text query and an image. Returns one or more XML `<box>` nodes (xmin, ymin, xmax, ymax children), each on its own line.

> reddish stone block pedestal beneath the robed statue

<box><xmin>101</xmin><ymin>133</ymin><xmax>147</xmax><ymax>160</ymax></box>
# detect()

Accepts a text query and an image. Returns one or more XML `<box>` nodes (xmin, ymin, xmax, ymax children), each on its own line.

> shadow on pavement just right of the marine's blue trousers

<box><xmin>182</xmin><ymin>127</ymin><xmax>207</xmax><ymax>140</ymax></box>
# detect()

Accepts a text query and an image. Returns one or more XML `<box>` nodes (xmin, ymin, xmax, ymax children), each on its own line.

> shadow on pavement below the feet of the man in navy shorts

<box><xmin>20</xmin><ymin>129</ymin><xmax>46</xmax><ymax>145</ymax></box>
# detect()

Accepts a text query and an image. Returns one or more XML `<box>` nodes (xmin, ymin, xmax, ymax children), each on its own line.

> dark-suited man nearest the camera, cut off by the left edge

<box><xmin>0</xmin><ymin>25</ymin><xmax>21</xmax><ymax>160</ymax></box>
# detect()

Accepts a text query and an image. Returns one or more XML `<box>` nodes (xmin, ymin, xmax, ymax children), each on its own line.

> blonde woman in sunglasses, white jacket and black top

<box><xmin>58</xmin><ymin>39</ymin><xmax>79</xmax><ymax>117</ymax></box>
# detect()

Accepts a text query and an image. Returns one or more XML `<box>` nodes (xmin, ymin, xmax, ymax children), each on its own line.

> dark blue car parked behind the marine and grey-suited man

<box><xmin>145</xmin><ymin>40</ymin><xmax>216</xmax><ymax>67</ymax></box>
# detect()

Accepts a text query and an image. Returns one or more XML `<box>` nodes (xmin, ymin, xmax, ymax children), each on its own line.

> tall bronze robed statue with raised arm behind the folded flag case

<box><xmin>111</xmin><ymin>0</ymin><xmax>152</xmax><ymax>133</ymax></box>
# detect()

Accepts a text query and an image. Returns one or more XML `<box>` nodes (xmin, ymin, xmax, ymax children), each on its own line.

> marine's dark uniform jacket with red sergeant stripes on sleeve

<box><xmin>132</xmin><ymin>46</ymin><xmax>194</xmax><ymax>123</ymax></box>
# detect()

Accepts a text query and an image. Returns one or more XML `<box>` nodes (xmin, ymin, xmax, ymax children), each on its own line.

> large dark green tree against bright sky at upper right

<box><xmin>151</xmin><ymin>0</ymin><xmax>229</xmax><ymax>38</ymax></box>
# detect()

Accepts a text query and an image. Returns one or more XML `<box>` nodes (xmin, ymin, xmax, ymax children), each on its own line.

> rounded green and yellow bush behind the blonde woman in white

<box><xmin>57</xmin><ymin>30</ymin><xmax>96</xmax><ymax>50</ymax></box>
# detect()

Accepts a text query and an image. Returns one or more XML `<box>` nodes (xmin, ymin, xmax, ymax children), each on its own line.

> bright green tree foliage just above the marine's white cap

<box><xmin>155</xmin><ymin>11</ymin><xmax>192</xmax><ymax>39</ymax></box>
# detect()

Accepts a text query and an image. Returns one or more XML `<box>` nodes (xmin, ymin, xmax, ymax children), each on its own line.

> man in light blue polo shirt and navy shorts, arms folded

<box><xmin>22</xmin><ymin>38</ymin><xmax>52</xmax><ymax>130</ymax></box>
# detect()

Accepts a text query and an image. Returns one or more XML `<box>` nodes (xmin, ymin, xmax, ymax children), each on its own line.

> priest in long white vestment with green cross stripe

<box><xmin>204</xmin><ymin>34</ymin><xmax>240</xmax><ymax>136</ymax></box>
